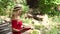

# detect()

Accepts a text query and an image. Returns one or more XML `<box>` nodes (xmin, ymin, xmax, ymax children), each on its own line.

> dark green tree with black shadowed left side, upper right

<box><xmin>27</xmin><ymin>0</ymin><xmax>60</xmax><ymax>16</ymax></box>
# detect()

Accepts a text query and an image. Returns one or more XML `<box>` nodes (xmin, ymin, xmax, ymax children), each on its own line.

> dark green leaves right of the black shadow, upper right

<box><xmin>38</xmin><ymin>0</ymin><xmax>60</xmax><ymax>16</ymax></box>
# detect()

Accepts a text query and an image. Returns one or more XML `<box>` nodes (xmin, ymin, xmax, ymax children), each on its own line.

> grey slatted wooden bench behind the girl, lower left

<box><xmin>0</xmin><ymin>23</ymin><xmax>12</xmax><ymax>34</ymax></box>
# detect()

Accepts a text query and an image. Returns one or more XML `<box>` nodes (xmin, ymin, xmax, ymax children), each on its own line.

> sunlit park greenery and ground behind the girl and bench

<box><xmin>0</xmin><ymin>0</ymin><xmax>60</xmax><ymax>34</ymax></box>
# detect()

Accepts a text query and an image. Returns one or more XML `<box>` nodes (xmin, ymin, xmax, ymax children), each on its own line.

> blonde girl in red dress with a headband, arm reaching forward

<box><xmin>11</xmin><ymin>6</ymin><xmax>30</xmax><ymax>34</ymax></box>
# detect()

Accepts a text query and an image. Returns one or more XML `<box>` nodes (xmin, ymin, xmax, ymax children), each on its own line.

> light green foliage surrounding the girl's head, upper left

<box><xmin>0</xmin><ymin>0</ymin><xmax>29</xmax><ymax>15</ymax></box>
